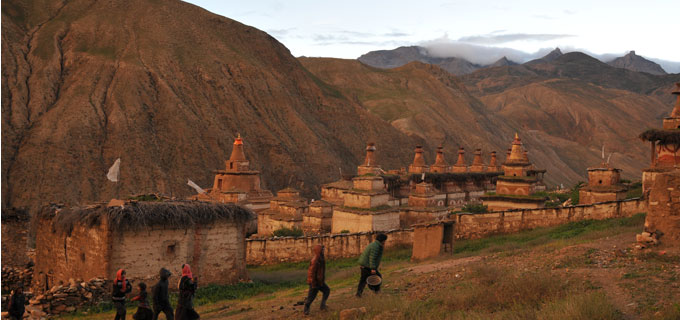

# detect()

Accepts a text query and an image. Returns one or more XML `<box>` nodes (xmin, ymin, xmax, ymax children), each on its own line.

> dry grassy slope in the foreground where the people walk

<box><xmin>61</xmin><ymin>215</ymin><xmax>680</xmax><ymax>319</ymax></box>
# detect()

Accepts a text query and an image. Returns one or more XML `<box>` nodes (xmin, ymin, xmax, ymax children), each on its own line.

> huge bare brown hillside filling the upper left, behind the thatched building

<box><xmin>2</xmin><ymin>0</ymin><xmax>422</xmax><ymax>209</ymax></box>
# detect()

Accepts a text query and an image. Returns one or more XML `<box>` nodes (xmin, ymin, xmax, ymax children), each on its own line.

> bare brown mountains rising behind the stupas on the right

<box><xmin>300</xmin><ymin>53</ymin><xmax>674</xmax><ymax>185</ymax></box>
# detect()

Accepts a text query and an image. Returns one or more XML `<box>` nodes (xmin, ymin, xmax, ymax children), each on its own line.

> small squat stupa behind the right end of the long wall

<box><xmin>579</xmin><ymin>163</ymin><xmax>628</xmax><ymax>204</ymax></box>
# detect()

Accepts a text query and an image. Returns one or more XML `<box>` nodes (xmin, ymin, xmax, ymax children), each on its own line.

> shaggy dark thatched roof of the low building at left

<box><xmin>39</xmin><ymin>200</ymin><xmax>255</xmax><ymax>233</ymax></box>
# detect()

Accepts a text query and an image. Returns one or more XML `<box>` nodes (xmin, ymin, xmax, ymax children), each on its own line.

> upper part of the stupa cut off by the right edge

<box><xmin>640</xmin><ymin>82</ymin><xmax>680</xmax><ymax>194</ymax></box>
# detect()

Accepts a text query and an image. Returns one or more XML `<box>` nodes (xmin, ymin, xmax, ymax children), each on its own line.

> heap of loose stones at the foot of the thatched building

<box><xmin>26</xmin><ymin>278</ymin><xmax>111</xmax><ymax>319</ymax></box>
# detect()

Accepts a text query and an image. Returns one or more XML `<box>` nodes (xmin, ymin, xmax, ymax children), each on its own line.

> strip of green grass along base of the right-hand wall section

<box><xmin>453</xmin><ymin>213</ymin><xmax>645</xmax><ymax>253</ymax></box>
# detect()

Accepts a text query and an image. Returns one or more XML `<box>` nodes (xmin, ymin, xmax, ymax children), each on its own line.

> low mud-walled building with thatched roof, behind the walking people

<box><xmin>33</xmin><ymin>200</ymin><xmax>254</xmax><ymax>292</ymax></box>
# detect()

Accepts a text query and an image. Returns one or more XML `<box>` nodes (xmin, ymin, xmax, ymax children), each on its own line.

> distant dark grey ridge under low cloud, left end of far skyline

<box><xmin>358</xmin><ymin>46</ymin><xmax>483</xmax><ymax>75</ymax></box>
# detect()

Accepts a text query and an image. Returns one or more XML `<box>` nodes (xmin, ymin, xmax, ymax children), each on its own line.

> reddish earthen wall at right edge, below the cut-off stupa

<box><xmin>645</xmin><ymin>170</ymin><xmax>680</xmax><ymax>246</ymax></box>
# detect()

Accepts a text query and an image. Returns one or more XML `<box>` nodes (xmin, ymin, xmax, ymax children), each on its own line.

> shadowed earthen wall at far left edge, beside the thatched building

<box><xmin>2</xmin><ymin>209</ymin><xmax>30</xmax><ymax>268</ymax></box>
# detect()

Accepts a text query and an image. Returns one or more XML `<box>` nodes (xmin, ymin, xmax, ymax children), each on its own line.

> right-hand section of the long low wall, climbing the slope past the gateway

<box><xmin>456</xmin><ymin>198</ymin><xmax>647</xmax><ymax>239</ymax></box>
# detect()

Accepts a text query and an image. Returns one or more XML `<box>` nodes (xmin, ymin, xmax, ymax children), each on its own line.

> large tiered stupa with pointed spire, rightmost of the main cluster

<box><xmin>482</xmin><ymin>134</ymin><xmax>547</xmax><ymax>211</ymax></box>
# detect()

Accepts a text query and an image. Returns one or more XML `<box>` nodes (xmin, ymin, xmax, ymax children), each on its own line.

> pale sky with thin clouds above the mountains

<box><xmin>188</xmin><ymin>0</ymin><xmax>680</xmax><ymax>72</ymax></box>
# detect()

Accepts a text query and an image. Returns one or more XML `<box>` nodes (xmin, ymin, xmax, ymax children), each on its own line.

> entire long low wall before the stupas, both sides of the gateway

<box><xmin>246</xmin><ymin>198</ymin><xmax>647</xmax><ymax>265</ymax></box>
